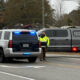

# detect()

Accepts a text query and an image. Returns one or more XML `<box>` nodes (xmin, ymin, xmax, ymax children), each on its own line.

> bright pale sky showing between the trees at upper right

<box><xmin>49</xmin><ymin>0</ymin><xmax>80</xmax><ymax>14</ymax></box>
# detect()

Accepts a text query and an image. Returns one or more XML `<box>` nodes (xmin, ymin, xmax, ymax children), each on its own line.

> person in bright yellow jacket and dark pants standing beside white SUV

<box><xmin>39</xmin><ymin>32</ymin><xmax>50</xmax><ymax>61</ymax></box>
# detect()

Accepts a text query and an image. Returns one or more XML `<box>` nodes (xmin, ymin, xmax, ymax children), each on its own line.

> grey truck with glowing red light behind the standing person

<box><xmin>37</xmin><ymin>28</ymin><xmax>80</xmax><ymax>52</ymax></box>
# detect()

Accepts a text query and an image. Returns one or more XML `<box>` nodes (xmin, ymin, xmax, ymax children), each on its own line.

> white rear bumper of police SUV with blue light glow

<box><xmin>4</xmin><ymin>48</ymin><xmax>41</xmax><ymax>57</ymax></box>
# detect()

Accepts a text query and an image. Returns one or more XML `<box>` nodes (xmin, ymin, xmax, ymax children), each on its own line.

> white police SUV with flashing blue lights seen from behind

<box><xmin>0</xmin><ymin>29</ymin><xmax>41</xmax><ymax>62</ymax></box>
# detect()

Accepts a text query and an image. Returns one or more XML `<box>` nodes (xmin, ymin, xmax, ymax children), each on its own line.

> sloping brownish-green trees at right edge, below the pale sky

<box><xmin>56</xmin><ymin>1</ymin><xmax>80</xmax><ymax>26</ymax></box>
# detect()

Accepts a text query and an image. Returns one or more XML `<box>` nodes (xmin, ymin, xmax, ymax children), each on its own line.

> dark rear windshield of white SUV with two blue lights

<box><xmin>12</xmin><ymin>32</ymin><xmax>38</xmax><ymax>42</ymax></box>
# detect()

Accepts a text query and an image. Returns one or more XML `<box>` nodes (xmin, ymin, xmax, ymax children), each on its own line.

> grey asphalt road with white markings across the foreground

<box><xmin>0</xmin><ymin>56</ymin><xmax>80</xmax><ymax>80</ymax></box>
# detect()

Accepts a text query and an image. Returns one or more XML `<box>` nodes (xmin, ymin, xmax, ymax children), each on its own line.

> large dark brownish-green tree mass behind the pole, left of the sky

<box><xmin>4</xmin><ymin>0</ymin><xmax>54</xmax><ymax>26</ymax></box>
